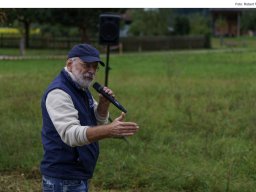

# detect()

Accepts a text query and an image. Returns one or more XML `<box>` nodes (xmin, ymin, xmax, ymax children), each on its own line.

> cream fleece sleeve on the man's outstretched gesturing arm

<box><xmin>46</xmin><ymin>89</ymin><xmax>89</xmax><ymax>147</ymax></box>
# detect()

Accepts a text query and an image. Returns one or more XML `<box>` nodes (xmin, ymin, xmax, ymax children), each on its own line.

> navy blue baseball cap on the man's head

<box><xmin>68</xmin><ymin>43</ymin><xmax>105</xmax><ymax>66</ymax></box>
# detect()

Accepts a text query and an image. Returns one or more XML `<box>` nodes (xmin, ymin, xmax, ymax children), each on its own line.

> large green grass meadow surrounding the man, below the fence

<box><xmin>0</xmin><ymin>49</ymin><xmax>256</xmax><ymax>192</ymax></box>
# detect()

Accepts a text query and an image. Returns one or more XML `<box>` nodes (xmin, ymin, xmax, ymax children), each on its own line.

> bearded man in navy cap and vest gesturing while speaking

<box><xmin>41</xmin><ymin>44</ymin><xmax>139</xmax><ymax>192</ymax></box>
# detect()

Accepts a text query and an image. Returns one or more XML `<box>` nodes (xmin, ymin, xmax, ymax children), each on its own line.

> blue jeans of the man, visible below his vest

<box><xmin>42</xmin><ymin>175</ymin><xmax>88</xmax><ymax>192</ymax></box>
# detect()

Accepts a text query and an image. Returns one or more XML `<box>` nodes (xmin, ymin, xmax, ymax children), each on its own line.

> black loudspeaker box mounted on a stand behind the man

<box><xmin>99</xmin><ymin>14</ymin><xmax>120</xmax><ymax>45</ymax></box>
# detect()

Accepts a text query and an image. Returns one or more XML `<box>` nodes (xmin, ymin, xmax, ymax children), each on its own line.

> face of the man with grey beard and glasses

<box><xmin>71</xmin><ymin>58</ymin><xmax>98</xmax><ymax>88</ymax></box>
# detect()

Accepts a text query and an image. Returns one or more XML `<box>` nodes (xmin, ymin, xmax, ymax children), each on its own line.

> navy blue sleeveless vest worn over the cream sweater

<box><xmin>41</xmin><ymin>69</ymin><xmax>99</xmax><ymax>180</ymax></box>
